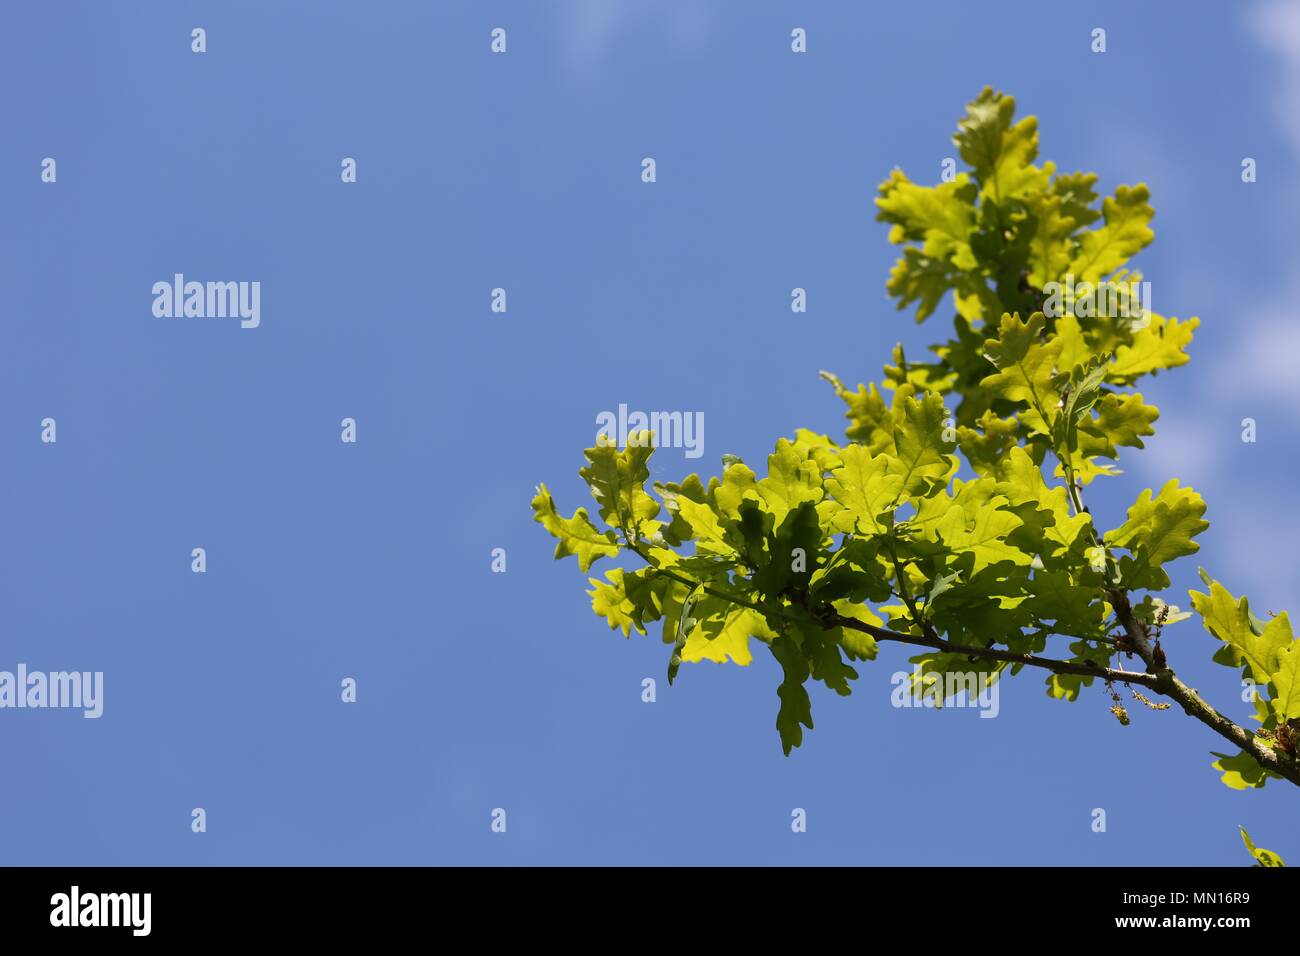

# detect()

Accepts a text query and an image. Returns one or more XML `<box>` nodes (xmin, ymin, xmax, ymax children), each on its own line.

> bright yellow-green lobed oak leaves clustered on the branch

<box><xmin>532</xmin><ymin>88</ymin><xmax>1300</xmax><ymax>788</ymax></box>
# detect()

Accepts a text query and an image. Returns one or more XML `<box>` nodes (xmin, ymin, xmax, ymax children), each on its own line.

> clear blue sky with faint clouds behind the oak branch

<box><xmin>0</xmin><ymin>0</ymin><xmax>1300</xmax><ymax>866</ymax></box>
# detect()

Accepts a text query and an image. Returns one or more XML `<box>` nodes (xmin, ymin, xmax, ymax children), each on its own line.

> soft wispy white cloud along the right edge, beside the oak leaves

<box><xmin>1128</xmin><ymin>0</ymin><xmax>1300</xmax><ymax>606</ymax></box>
